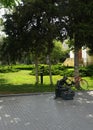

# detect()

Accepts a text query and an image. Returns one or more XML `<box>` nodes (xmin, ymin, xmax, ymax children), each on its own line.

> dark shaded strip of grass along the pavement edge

<box><xmin>0</xmin><ymin>82</ymin><xmax>55</xmax><ymax>94</ymax></box>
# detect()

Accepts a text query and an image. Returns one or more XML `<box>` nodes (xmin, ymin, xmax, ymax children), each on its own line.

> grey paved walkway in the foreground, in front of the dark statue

<box><xmin>0</xmin><ymin>91</ymin><xmax>93</xmax><ymax>130</ymax></box>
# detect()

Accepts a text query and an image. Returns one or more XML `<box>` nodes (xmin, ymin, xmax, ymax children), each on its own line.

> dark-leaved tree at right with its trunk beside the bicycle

<box><xmin>59</xmin><ymin>0</ymin><xmax>93</xmax><ymax>86</ymax></box>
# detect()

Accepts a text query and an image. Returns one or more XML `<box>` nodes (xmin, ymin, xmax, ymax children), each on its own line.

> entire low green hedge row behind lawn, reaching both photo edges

<box><xmin>0</xmin><ymin>64</ymin><xmax>93</xmax><ymax>77</ymax></box>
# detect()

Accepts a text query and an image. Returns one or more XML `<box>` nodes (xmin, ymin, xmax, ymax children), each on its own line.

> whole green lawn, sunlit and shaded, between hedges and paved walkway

<box><xmin>0</xmin><ymin>70</ymin><xmax>93</xmax><ymax>94</ymax></box>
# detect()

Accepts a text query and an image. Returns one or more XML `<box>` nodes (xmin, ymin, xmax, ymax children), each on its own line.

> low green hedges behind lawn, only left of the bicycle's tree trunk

<box><xmin>0</xmin><ymin>64</ymin><xmax>73</xmax><ymax>76</ymax></box>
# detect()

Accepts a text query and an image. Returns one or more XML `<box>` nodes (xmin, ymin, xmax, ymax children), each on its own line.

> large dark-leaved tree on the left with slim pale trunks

<box><xmin>1</xmin><ymin>0</ymin><xmax>62</xmax><ymax>84</ymax></box>
